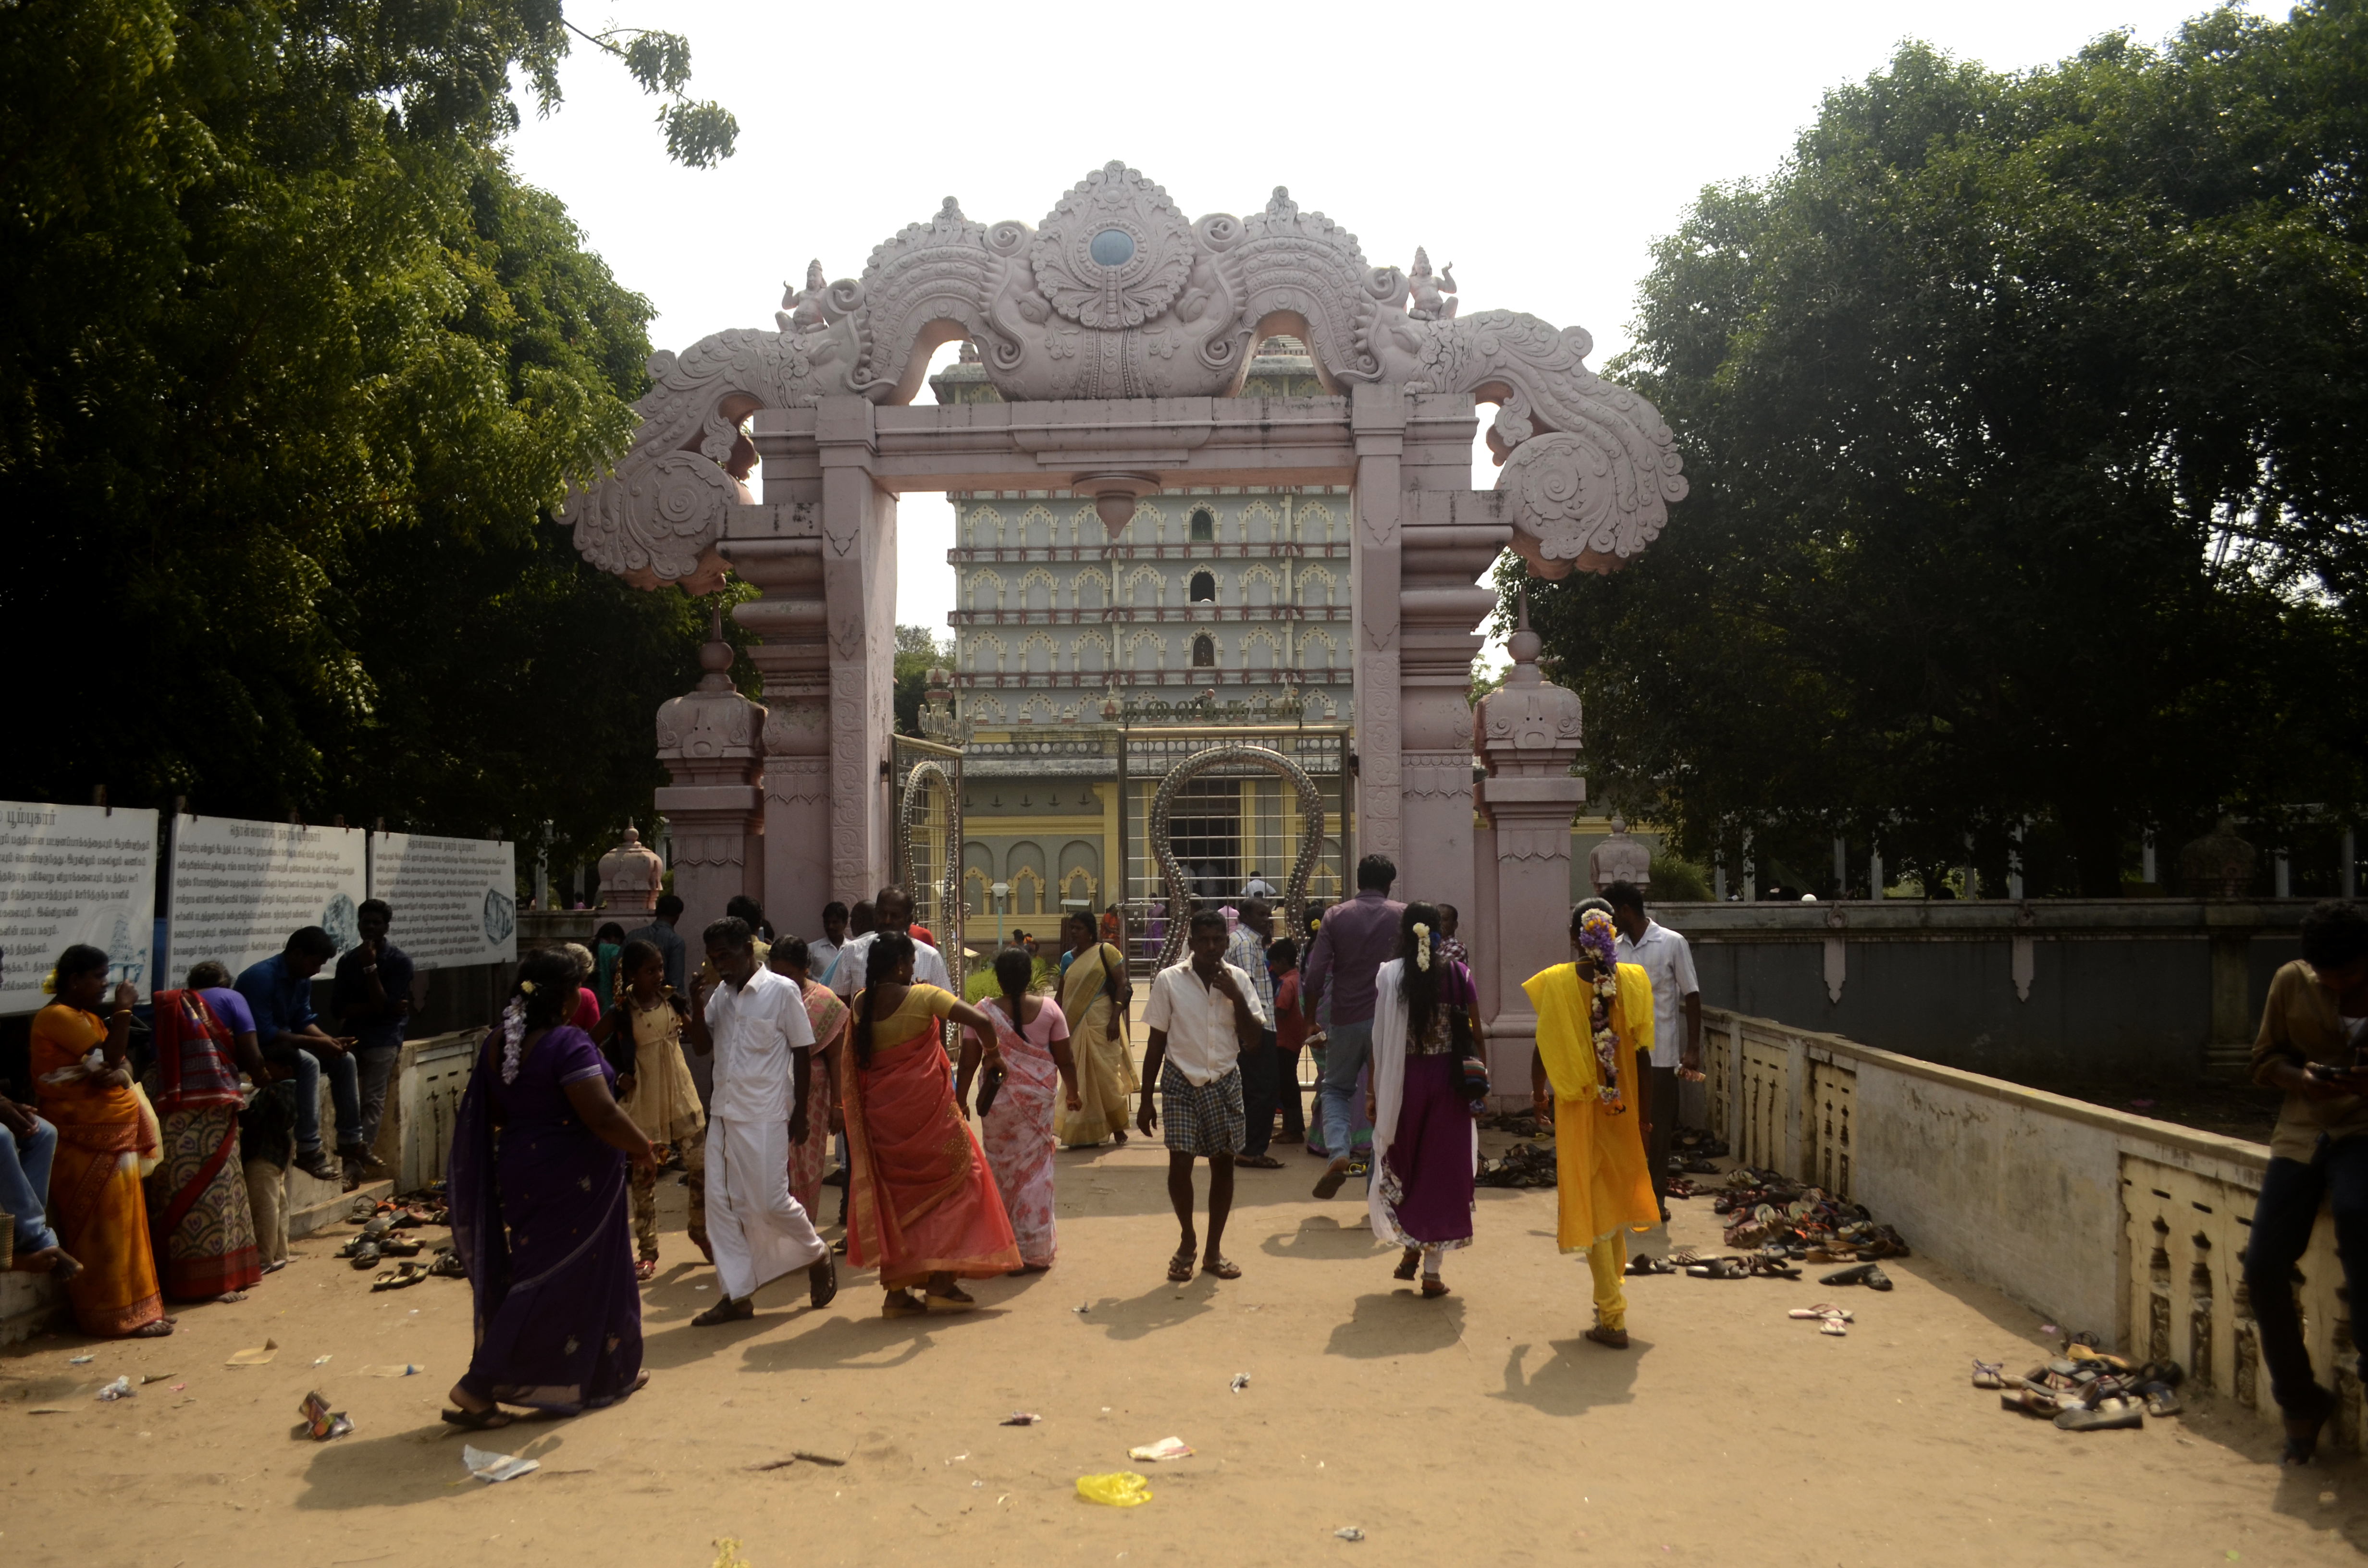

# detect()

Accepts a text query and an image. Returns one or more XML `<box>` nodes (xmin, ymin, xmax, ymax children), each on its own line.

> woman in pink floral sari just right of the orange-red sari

<box><xmin>954</xmin><ymin>947</ymin><xmax>1085</xmax><ymax>1274</ymax></box>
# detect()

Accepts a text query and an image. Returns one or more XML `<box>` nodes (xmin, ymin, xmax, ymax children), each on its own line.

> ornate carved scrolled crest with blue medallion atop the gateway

<box><xmin>564</xmin><ymin>163</ymin><xmax>1686</xmax><ymax>592</ymax></box>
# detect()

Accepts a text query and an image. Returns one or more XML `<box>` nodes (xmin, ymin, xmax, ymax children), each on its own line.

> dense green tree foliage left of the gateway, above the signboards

<box><xmin>0</xmin><ymin>0</ymin><xmax>729</xmax><ymax>871</ymax></box>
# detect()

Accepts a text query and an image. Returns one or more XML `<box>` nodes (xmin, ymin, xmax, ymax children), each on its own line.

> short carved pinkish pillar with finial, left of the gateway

<box><xmin>658</xmin><ymin>621</ymin><xmax>765</xmax><ymax>947</ymax></box>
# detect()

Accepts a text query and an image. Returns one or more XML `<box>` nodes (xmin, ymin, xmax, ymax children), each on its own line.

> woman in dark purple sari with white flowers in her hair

<box><xmin>443</xmin><ymin>950</ymin><xmax>656</xmax><ymax>1431</ymax></box>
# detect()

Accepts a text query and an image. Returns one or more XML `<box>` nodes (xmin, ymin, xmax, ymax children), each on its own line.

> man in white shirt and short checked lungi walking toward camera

<box><xmin>1135</xmin><ymin>909</ymin><xmax>1274</xmax><ymax>1284</ymax></box>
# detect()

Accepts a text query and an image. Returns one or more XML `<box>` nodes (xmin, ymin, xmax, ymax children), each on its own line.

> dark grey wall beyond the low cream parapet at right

<box><xmin>1653</xmin><ymin>900</ymin><xmax>2309</xmax><ymax>1082</ymax></box>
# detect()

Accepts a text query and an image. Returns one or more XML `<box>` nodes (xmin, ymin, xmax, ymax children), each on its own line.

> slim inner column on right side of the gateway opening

<box><xmin>1347</xmin><ymin>381</ymin><xmax>1418</xmax><ymax>867</ymax></box>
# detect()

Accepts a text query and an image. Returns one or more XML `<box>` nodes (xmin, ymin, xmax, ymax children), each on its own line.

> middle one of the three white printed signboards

<box><xmin>168</xmin><ymin>817</ymin><xmax>370</xmax><ymax>983</ymax></box>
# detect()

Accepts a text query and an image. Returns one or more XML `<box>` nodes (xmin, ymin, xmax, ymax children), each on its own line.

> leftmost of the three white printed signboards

<box><xmin>0</xmin><ymin>801</ymin><xmax>156</xmax><ymax>1014</ymax></box>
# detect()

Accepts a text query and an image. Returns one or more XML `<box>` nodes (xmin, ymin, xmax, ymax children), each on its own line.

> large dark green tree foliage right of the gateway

<box><xmin>1532</xmin><ymin>0</ymin><xmax>2368</xmax><ymax>893</ymax></box>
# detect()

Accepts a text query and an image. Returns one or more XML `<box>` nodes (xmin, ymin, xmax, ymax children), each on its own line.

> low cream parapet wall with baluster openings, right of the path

<box><xmin>1702</xmin><ymin>1009</ymin><xmax>2339</xmax><ymax>1447</ymax></box>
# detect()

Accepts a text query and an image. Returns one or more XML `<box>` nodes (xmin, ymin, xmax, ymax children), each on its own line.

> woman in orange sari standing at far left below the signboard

<box><xmin>33</xmin><ymin>943</ymin><xmax>173</xmax><ymax>1338</ymax></box>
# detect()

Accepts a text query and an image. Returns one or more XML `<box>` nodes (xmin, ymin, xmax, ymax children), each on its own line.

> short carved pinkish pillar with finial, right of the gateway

<box><xmin>1470</xmin><ymin>595</ymin><xmax>1587</xmax><ymax>1104</ymax></box>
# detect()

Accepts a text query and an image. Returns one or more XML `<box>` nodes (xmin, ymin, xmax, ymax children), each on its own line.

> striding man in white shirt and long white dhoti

<box><xmin>689</xmin><ymin>917</ymin><xmax>839</xmax><ymax>1329</ymax></box>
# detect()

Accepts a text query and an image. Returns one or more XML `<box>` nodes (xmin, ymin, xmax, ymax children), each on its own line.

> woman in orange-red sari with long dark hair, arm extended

<box><xmin>843</xmin><ymin>931</ymin><xmax>1021</xmax><ymax>1317</ymax></box>
